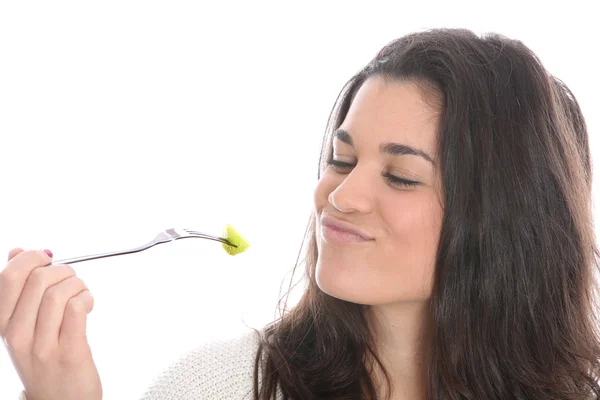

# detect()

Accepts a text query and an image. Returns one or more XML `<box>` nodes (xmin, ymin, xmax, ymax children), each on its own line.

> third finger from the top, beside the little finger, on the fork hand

<box><xmin>33</xmin><ymin>275</ymin><xmax>87</xmax><ymax>352</ymax></box>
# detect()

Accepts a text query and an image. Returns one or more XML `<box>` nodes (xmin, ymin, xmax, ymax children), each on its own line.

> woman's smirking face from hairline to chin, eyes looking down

<box><xmin>314</xmin><ymin>76</ymin><xmax>442</xmax><ymax>305</ymax></box>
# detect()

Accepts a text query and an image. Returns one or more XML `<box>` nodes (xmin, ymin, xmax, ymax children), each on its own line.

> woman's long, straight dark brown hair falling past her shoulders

<box><xmin>254</xmin><ymin>29</ymin><xmax>600</xmax><ymax>400</ymax></box>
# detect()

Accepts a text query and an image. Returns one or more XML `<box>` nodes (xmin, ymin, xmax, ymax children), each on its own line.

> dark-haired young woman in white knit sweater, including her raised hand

<box><xmin>0</xmin><ymin>29</ymin><xmax>600</xmax><ymax>400</ymax></box>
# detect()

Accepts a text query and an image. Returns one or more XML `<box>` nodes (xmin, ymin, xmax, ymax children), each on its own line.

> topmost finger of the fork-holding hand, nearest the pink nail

<box><xmin>0</xmin><ymin>249</ymin><xmax>52</xmax><ymax>336</ymax></box>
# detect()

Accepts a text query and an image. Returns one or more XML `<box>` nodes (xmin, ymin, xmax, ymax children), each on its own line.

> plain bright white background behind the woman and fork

<box><xmin>0</xmin><ymin>0</ymin><xmax>600</xmax><ymax>399</ymax></box>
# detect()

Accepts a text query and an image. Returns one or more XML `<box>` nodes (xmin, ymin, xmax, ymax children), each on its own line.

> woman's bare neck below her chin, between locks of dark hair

<box><xmin>369</xmin><ymin>302</ymin><xmax>429</xmax><ymax>400</ymax></box>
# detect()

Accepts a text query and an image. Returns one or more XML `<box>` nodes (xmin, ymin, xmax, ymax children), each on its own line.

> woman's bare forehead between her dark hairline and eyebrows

<box><xmin>340</xmin><ymin>76</ymin><xmax>441</xmax><ymax>155</ymax></box>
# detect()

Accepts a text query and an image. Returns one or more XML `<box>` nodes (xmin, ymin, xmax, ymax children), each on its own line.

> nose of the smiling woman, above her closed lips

<box><xmin>327</xmin><ymin>169</ymin><xmax>373</xmax><ymax>213</ymax></box>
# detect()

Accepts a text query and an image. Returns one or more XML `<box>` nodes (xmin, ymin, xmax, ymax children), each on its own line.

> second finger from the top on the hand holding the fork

<box><xmin>6</xmin><ymin>265</ymin><xmax>75</xmax><ymax>348</ymax></box>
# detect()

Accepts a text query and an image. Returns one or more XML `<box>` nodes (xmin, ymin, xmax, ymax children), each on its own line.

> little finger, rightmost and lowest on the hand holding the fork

<box><xmin>59</xmin><ymin>290</ymin><xmax>94</xmax><ymax>356</ymax></box>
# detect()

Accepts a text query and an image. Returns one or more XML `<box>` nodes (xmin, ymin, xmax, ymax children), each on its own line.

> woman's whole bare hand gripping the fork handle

<box><xmin>0</xmin><ymin>248</ymin><xmax>102</xmax><ymax>400</ymax></box>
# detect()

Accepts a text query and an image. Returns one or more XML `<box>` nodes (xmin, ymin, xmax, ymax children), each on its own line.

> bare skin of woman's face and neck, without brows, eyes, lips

<box><xmin>314</xmin><ymin>77</ymin><xmax>443</xmax><ymax>399</ymax></box>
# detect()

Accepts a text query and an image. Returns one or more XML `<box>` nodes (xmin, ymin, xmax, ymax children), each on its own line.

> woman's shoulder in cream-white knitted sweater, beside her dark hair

<box><xmin>142</xmin><ymin>331</ymin><xmax>259</xmax><ymax>400</ymax></box>
